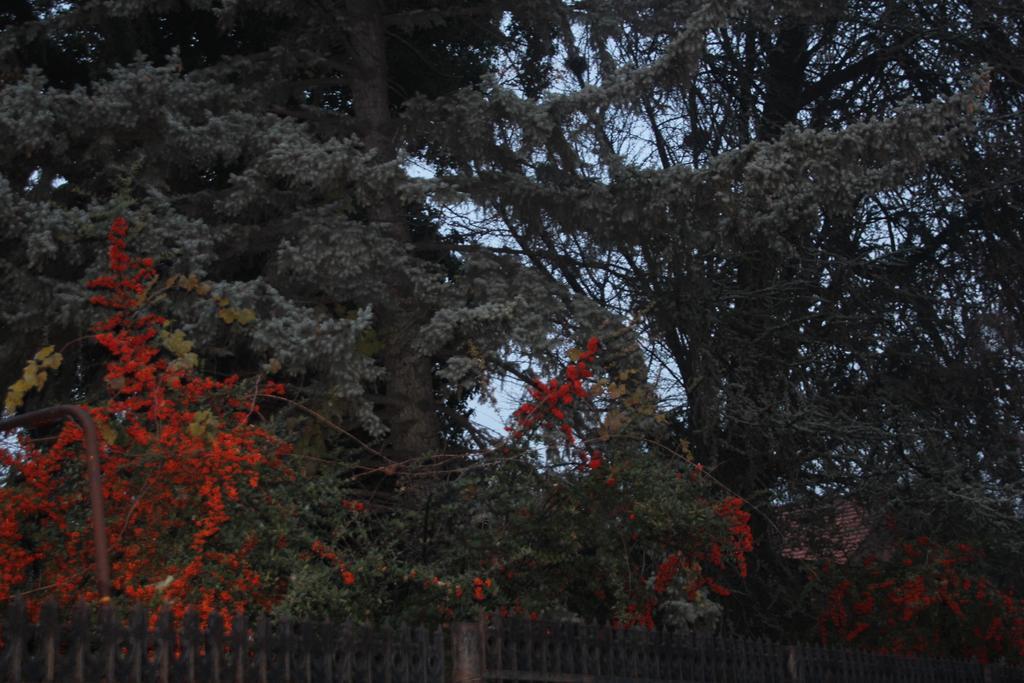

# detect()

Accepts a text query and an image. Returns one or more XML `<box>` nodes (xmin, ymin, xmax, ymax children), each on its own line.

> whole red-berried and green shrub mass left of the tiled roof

<box><xmin>0</xmin><ymin>218</ymin><xmax>752</xmax><ymax>628</ymax></box>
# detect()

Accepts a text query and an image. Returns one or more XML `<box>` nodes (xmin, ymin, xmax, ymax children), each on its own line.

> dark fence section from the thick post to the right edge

<box><xmin>452</xmin><ymin>620</ymin><xmax>1024</xmax><ymax>683</ymax></box>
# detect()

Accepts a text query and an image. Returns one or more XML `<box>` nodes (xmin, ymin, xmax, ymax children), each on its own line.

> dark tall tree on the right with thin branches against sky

<box><xmin>405</xmin><ymin>2</ymin><xmax>1024</xmax><ymax>632</ymax></box>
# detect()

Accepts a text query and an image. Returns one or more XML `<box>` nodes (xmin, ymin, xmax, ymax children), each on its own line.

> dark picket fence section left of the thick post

<box><xmin>0</xmin><ymin>601</ymin><xmax>445</xmax><ymax>683</ymax></box>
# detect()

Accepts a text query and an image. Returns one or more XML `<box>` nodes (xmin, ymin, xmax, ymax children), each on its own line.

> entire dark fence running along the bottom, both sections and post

<box><xmin>0</xmin><ymin>601</ymin><xmax>1024</xmax><ymax>683</ymax></box>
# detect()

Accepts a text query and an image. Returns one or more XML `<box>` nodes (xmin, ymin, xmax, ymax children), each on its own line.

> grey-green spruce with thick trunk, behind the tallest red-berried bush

<box><xmin>0</xmin><ymin>2</ymin><xmax>663</xmax><ymax>617</ymax></box>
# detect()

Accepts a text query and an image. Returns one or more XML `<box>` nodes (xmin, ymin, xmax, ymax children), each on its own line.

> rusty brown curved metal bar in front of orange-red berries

<box><xmin>0</xmin><ymin>405</ymin><xmax>111</xmax><ymax>602</ymax></box>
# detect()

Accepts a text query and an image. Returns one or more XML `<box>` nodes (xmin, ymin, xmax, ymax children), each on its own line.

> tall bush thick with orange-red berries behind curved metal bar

<box><xmin>0</xmin><ymin>220</ymin><xmax>288</xmax><ymax>618</ymax></box>
